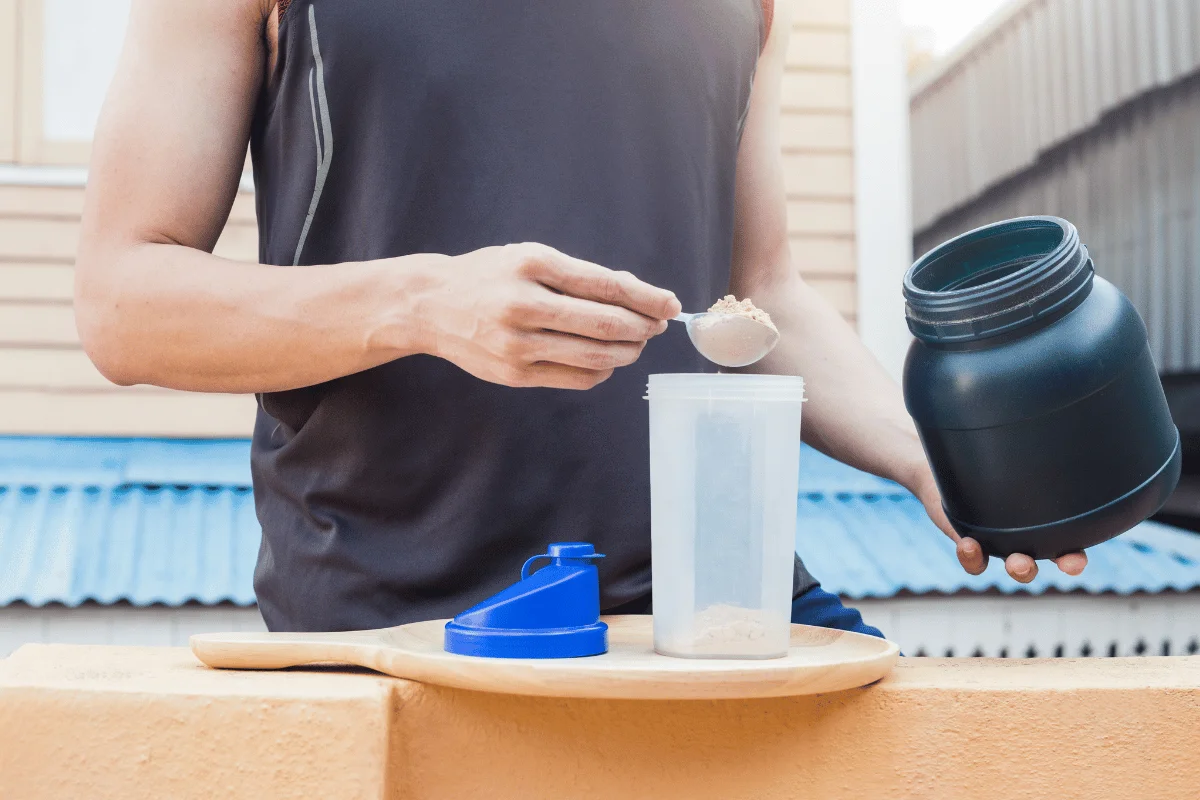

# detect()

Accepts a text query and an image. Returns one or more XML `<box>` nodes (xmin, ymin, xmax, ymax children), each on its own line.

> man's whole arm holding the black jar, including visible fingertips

<box><xmin>730</xmin><ymin>0</ymin><xmax>1087</xmax><ymax>583</ymax></box>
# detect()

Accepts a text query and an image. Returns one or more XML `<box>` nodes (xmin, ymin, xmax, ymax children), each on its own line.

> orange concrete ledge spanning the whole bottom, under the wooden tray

<box><xmin>0</xmin><ymin>646</ymin><xmax>1200</xmax><ymax>800</ymax></box>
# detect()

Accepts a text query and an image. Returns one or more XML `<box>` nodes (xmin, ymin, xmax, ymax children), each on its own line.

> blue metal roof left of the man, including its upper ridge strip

<box><xmin>0</xmin><ymin>438</ymin><xmax>262</xmax><ymax>606</ymax></box>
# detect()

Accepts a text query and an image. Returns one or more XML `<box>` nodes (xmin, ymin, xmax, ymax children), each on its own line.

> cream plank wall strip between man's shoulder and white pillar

<box><xmin>782</xmin><ymin>0</ymin><xmax>858</xmax><ymax>323</ymax></box>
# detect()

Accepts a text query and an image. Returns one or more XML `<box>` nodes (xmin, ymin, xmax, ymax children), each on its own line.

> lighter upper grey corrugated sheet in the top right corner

<box><xmin>911</xmin><ymin>0</ymin><xmax>1200</xmax><ymax>230</ymax></box>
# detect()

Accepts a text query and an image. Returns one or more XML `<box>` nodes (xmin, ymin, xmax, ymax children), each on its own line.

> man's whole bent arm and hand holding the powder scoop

<box><xmin>76</xmin><ymin>0</ymin><xmax>678</xmax><ymax>392</ymax></box>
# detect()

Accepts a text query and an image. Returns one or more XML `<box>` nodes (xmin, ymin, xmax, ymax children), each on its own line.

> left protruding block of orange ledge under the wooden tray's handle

<box><xmin>0</xmin><ymin>645</ymin><xmax>392</xmax><ymax>800</ymax></box>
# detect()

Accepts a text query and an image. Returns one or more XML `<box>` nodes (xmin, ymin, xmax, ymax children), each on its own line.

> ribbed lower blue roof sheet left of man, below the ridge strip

<box><xmin>0</xmin><ymin>486</ymin><xmax>260</xmax><ymax>606</ymax></box>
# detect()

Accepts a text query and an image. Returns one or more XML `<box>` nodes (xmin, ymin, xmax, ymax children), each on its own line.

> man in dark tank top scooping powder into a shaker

<box><xmin>77</xmin><ymin>0</ymin><xmax>1085</xmax><ymax>630</ymax></box>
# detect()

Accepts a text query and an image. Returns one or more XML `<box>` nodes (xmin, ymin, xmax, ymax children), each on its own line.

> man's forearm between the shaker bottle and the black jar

<box><xmin>734</xmin><ymin>271</ymin><xmax>925</xmax><ymax>487</ymax></box>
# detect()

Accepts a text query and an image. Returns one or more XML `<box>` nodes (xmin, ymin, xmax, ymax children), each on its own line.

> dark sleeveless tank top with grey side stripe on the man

<box><xmin>252</xmin><ymin>0</ymin><xmax>812</xmax><ymax>630</ymax></box>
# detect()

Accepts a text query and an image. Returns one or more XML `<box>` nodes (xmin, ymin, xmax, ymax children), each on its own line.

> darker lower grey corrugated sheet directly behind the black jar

<box><xmin>913</xmin><ymin>67</ymin><xmax>1200</xmax><ymax>373</ymax></box>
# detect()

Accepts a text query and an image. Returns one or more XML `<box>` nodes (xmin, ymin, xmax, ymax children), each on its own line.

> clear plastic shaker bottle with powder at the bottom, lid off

<box><xmin>647</xmin><ymin>374</ymin><xmax>804</xmax><ymax>658</ymax></box>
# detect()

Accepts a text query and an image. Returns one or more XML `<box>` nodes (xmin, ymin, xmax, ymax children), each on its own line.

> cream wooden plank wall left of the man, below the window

<box><xmin>0</xmin><ymin>186</ymin><xmax>258</xmax><ymax>437</ymax></box>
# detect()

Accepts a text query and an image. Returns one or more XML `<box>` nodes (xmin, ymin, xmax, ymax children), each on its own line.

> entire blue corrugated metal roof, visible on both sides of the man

<box><xmin>0</xmin><ymin>438</ymin><xmax>1200</xmax><ymax>606</ymax></box>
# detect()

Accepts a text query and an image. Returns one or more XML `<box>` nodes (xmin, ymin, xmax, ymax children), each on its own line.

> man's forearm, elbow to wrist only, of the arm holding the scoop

<box><xmin>76</xmin><ymin>242</ymin><xmax>444</xmax><ymax>393</ymax></box>
